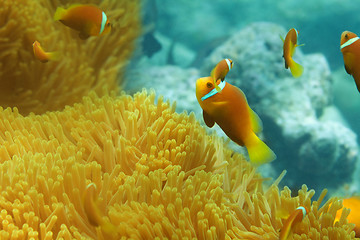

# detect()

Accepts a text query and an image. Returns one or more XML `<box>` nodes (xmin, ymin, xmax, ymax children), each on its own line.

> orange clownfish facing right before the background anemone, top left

<box><xmin>54</xmin><ymin>4</ymin><xmax>111</xmax><ymax>39</ymax></box>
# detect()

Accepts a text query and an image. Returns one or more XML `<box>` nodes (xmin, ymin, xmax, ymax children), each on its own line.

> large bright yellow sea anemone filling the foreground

<box><xmin>0</xmin><ymin>90</ymin><xmax>355</xmax><ymax>239</ymax></box>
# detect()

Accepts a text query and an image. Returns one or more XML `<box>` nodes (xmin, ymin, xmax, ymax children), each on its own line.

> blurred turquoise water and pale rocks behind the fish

<box><xmin>125</xmin><ymin>0</ymin><xmax>360</xmax><ymax>199</ymax></box>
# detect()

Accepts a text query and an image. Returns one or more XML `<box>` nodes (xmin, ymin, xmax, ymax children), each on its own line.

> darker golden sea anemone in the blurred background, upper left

<box><xmin>0</xmin><ymin>0</ymin><xmax>141</xmax><ymax>114</ymax></box>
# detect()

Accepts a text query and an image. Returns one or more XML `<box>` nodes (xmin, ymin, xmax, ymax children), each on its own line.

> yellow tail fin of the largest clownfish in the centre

<box><xmin>245</xmin><ymin>133</ymin><xmax>276</xmax><ymax>165</ymax></box>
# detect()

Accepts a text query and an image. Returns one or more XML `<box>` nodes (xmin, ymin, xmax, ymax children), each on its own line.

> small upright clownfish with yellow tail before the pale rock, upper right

<box><xmin>281</xmin><ymin>28</ymin><xmax>304</xmax><ymax>78</ymax></box>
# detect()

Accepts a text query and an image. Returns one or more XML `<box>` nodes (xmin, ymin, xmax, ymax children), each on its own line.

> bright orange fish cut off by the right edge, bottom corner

<box><xmin>335</xmin><ymin>197</ymin><xmax>360</xmax><ymax>238</ymax></box>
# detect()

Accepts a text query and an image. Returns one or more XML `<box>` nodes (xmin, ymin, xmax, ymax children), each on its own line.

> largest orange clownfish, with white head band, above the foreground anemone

<box><xmin>196</xmin><ymin>77</ymin><xmax>276</xmax><ymax>165</ymax></box>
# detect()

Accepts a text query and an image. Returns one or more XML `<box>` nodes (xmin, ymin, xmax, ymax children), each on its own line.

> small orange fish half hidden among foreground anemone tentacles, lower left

<box><xmin>83</xmin><ymin>183</ymin><xmax>117</xmax><ymax>236</ymax></box>
